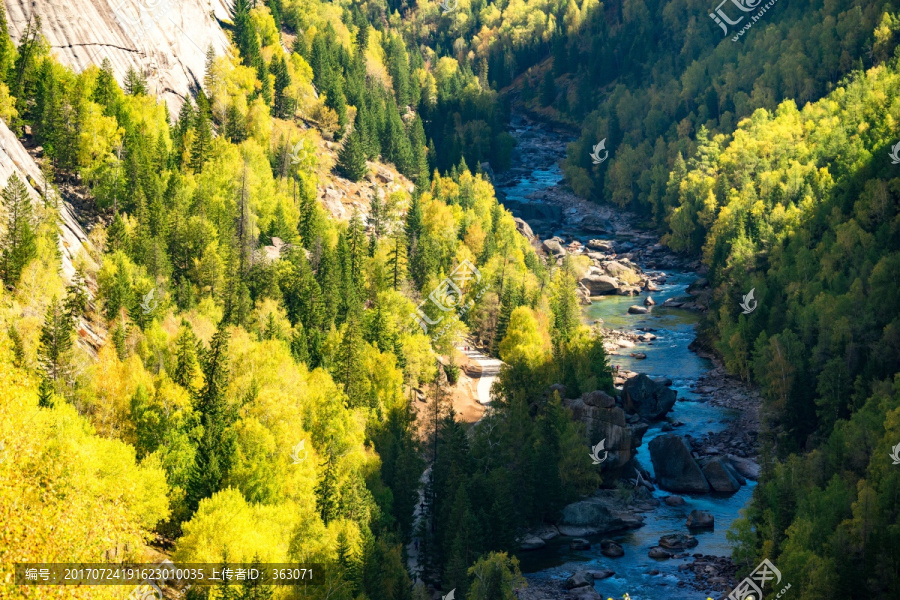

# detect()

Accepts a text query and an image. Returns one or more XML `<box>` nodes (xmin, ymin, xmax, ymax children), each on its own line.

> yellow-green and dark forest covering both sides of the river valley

<box><xmin>0</xmin><ymin>0</ymin><xmax>900</xmax><ymax>600</ymax></box>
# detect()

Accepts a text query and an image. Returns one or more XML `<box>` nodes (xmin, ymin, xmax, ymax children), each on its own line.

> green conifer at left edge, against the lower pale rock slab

<box><xmin>0</xmin><ymin>173</ymin><xmax>37</xmax><ymax>285</ymax></box>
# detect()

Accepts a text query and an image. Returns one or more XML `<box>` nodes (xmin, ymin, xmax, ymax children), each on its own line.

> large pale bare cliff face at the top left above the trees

<box><xmin>6</xmin><ymin>0</ymin><xmax>232</xmax><ymax>114</ymax></box>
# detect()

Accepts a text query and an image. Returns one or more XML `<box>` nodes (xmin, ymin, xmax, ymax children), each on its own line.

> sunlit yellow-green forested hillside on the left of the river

<box><xmin>0</xmin><ymin>0</ymin><xmax>610</xmax><ymax>600</ymax></box>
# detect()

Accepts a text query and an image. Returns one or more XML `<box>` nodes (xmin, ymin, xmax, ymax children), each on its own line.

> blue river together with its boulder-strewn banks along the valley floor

<box><xmin>495</xmin><ymin>116</ymin><xmax>759</xmax><ymax>600</ymax></box>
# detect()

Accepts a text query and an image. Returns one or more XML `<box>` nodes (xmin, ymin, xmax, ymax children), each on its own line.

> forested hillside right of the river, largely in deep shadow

<box><xmin>532</xmin><ymin>2</ymin><xmax>900</xmax><ymax>598</ymax></box>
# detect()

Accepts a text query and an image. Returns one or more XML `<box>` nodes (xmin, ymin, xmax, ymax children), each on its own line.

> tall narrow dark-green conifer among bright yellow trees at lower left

<box><xmin>187</xmin><ymin>320</ymin><xmax>234</xmax><ymax>511</ymax></box>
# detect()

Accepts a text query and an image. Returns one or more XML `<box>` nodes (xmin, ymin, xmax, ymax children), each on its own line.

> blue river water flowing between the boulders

<box><xmin>497</xmin><ymin>117</ymin><xmax>755</xmax><ymax>600</ymax></box>
